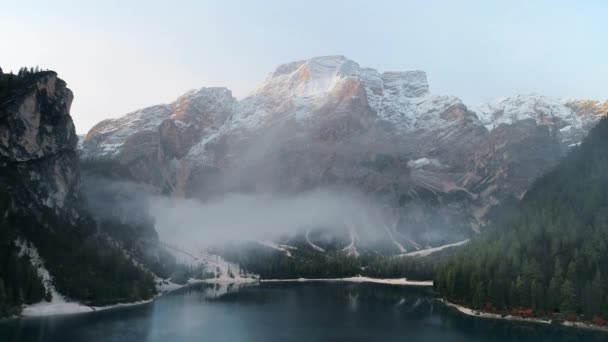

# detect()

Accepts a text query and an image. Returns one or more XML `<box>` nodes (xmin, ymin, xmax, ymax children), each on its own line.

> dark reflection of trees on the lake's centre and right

<box><xmin>167</xmin><ymin>282</ymin><xmax>606</xmax><ymax>341</ymax></box>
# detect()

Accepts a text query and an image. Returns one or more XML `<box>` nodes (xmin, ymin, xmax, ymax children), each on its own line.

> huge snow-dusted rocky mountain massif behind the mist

<box><xmin>81</xmin><ymin>56</ymin><xmax>608</xmax><ymax>253</ymax></box>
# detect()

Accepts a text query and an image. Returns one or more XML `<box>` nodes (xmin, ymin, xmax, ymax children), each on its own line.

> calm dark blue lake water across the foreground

<box><xmin>0</xmin><ymin>282</ymin><xmax>608</xmax><ymax>342</ymax></box>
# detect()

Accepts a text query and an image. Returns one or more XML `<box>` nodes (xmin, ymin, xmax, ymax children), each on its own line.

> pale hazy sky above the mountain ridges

<box><xmin>0</xmin><ymin>0</ymin><xmax>608</xmax><ymax>133</ymax></box>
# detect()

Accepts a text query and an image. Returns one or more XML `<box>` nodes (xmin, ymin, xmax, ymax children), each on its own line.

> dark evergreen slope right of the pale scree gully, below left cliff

<box><xmin>9</xmin><ymin>208</ymin><xmax>156</xmax><ymax>305</ymax></box>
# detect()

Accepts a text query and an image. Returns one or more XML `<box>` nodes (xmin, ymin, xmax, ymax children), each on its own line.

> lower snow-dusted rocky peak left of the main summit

<box><xmin>81</xmin><ymin>88</ymin><xmax>235</xmax><ymax>194</ymax></box>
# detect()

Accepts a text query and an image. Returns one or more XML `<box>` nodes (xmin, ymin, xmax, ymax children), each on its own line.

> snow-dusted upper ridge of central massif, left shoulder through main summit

<box><xmin>81</xmin><ymin>56</ymin><xmax>481</xmax><ymax>177</ymax></box>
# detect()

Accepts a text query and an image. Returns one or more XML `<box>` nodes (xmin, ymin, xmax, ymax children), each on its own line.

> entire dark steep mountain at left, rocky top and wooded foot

<box><xmin>0</xmin><ymin>70</ymin><xmax>156</xmax><ymax>316</ymax></box>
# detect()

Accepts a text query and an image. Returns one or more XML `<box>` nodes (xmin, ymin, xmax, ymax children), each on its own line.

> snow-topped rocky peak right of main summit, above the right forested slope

<box><xmin>470</xmin><ymin>94</ymin><xmax>593</xmax><ymax>218</ymax></box>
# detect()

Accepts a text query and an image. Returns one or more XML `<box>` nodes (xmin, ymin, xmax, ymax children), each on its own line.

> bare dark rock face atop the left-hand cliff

<box><xmin>0</xmin><ymin>71</ymin><xmax>79</xmax><ymax>219</ymax></box>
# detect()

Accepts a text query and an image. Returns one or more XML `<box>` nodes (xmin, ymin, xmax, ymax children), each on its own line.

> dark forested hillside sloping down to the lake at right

<box><xmin>435</xmin><ymin>118</ymin><xmax>608</xmax><ymax>324</ymax></box>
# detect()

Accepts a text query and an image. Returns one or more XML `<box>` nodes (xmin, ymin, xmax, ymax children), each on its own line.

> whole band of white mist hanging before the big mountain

<box><xmin>83</xmin><ymin>177</ymin><xmax>467</xmax><ymax>252</ymax></box>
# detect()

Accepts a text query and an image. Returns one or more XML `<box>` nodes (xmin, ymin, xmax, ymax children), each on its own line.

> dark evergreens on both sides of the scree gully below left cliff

<box><xmin>0</xmin><ymin>207</ymin><xmax>156</xmax><ymax>317</ymax></box>
